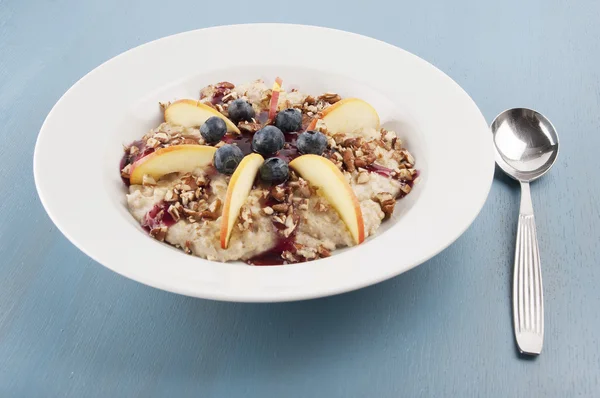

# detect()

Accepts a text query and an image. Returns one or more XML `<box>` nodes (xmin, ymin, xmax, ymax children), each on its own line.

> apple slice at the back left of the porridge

<box><xmin>165</xmin><ymin>99</ymin><xmax>240</xmax><ymax>134</ymax></box>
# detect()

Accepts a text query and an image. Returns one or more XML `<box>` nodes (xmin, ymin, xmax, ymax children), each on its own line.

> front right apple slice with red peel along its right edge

<box><xmin>290</xmin><ymin>155</ymin><xmax>365</xmax><ymax>245</ymax></box>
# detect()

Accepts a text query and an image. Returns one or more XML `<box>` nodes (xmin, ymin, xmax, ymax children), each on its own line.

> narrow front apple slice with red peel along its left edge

<box><xmin>221</xmin><ymin>153</ymin><xmax>265</xmax><ymax>249</ymax></box>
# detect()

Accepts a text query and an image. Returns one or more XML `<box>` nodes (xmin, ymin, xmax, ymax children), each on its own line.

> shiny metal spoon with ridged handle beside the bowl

<box><xmin>491</xmin><ymin>108</ymin><xmax>558</xmax><ymax>355</ymax></box>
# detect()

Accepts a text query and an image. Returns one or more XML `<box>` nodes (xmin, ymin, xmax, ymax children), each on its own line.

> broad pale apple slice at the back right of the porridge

<box><xmin>315</xmin><ymin>98</ymin><xmax>379</xmax><ymax>135</ymax></box>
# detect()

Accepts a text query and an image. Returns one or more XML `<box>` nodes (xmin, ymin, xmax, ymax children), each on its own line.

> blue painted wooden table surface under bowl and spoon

<box><xmin>0</xmin><ymin>0</ymin><xmax>600</xmax><ymax>398</ymax></box>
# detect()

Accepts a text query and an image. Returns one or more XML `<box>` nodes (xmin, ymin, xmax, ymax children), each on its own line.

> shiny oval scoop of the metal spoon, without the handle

<box><xmin>491</xmin><ymin>108</ymin><xmax>558</xmax><ymax>182</ymax></box>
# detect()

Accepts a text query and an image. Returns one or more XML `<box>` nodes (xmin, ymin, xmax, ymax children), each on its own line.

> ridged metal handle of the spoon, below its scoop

<box><xmin>513</xmin><ymin>182</ymin><xmax>544</xmax><ymax>355</ymax></box>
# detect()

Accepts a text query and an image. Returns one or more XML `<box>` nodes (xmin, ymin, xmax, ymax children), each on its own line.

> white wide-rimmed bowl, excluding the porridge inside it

<box><xmin>34</xmin><ymin>24</ymin><xmax>494</xmax><ymax>302</ymax></box>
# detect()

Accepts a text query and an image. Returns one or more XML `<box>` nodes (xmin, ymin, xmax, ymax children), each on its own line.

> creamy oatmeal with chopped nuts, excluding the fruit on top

<box><xmin>121</xmin><ymin>81</ymin><xmax>418</xmax><ymax>265</ymax></box>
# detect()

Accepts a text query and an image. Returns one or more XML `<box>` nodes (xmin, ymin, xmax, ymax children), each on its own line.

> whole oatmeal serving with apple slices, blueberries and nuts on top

<box><xmin>120</xmin><ymin>79</ymin><xmax>418</xmax><ymax>265</ymax></box>
